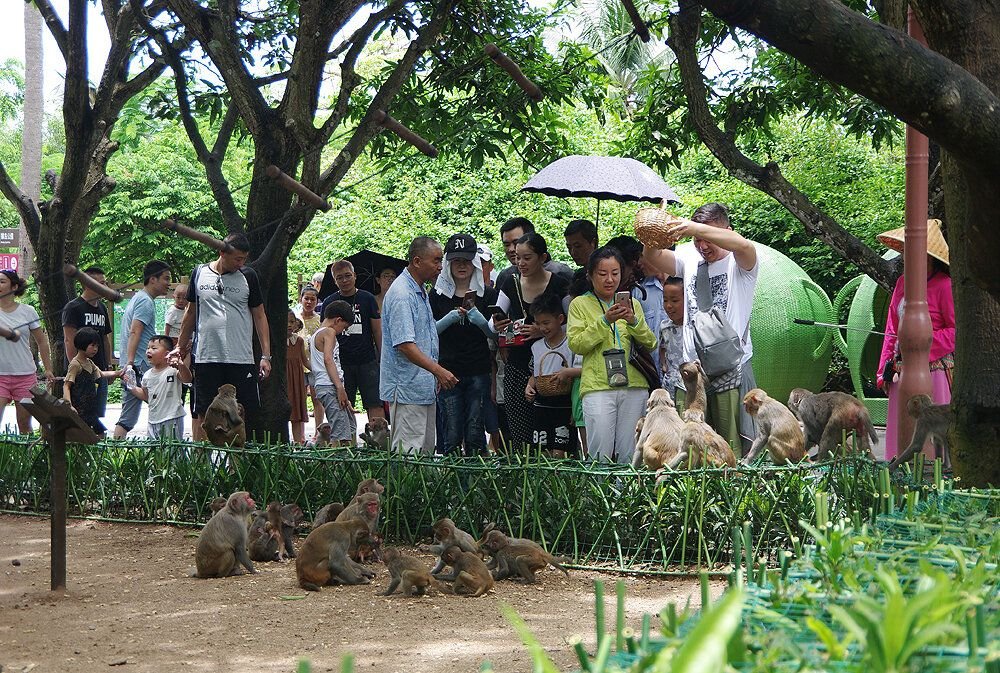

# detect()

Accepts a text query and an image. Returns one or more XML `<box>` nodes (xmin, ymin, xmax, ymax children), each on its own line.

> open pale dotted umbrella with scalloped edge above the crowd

<box><xmin>521</xmin><ymin>154</ymin><xmax>680</xmax><ymax>219</ymax></box>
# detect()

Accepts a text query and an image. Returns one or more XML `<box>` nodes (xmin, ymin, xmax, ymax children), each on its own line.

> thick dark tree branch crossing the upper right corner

<box><xmin>702</xmin><ymin>0</ymin><xmax>1000</xmax><ymax>172</ymax></box>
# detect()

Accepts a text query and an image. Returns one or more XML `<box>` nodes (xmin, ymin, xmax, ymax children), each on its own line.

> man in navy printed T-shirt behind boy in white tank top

<box><xmin>319</xmin><ymin>259</ymin><xmax>385</xmax><ymax>426</ymax></box>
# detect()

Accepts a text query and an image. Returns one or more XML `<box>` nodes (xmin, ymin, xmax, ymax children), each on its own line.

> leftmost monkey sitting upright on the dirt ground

<box><xmin>194</xmin><ymin>491</ymin><xmax>257</xmax><ymax>577</ymax></box>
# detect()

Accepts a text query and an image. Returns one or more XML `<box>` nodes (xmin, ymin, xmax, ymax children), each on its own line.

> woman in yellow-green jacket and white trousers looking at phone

<box><xmin>566</xmin><ymin>247</ymin><xmax>656</xmax><ymax>463</ymax></box>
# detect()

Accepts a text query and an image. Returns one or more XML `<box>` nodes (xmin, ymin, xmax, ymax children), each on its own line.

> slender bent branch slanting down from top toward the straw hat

<box><xmin>667</xmin><ymin>2</ymin><xmax>896</xmax><ymax>291</ymax></box>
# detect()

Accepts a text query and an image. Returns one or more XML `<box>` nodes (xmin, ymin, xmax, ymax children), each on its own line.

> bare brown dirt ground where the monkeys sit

<box><xmin>0</xmin><ymin>515</ymin><xmax>722</xmax><ymax>673</ymax></box>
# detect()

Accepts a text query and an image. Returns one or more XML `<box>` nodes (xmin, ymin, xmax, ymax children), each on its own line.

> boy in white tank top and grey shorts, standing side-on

<box><xmin>309</xmin><ymin>299</ymin><xmax>358</xmax><ymax>446</ymax></box>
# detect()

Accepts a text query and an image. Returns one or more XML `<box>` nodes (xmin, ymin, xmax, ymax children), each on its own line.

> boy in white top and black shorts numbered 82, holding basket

<box><xmin>524</xmin><ymin>294</ymin><xmax>582</xmax><ymax>458</ymax></box>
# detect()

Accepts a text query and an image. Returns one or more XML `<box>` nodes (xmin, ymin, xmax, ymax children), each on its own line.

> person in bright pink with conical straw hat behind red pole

<box><xmin>876</xmin><ymin>220</ymin><xmax>955</xmax><ymax>460</ymax></box>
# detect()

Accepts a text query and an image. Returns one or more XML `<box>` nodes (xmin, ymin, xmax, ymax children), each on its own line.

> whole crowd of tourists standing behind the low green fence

<box><xmin>0</xmin><ymin>203</ymin><xmax>954</xmax><ymax>462</ymax></box>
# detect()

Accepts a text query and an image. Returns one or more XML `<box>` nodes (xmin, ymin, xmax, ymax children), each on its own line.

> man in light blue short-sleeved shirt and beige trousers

<box><xmin>379</xmin><ymin>236</ymin><xmax>458</xmax><ymax>455</ymax></box>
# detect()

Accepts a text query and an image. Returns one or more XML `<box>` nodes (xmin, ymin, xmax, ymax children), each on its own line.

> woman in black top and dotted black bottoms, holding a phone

<box><xmin>492</xmin><ymin>233</ymin><xmax>569</xmax><ymax>449</ymax></box>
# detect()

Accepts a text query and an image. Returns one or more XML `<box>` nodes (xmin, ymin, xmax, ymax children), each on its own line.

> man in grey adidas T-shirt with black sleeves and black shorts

<box><xmin>173</xmin><ymin>233</ymin><xmax>271</xmax><ymax>440</ymax></box>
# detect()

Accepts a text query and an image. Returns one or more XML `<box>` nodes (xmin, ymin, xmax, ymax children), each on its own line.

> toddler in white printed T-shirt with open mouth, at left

<box><xmin>129</xmin><ymin>335</ymin><xmax>191</xmax><ymax>439</ymax></box>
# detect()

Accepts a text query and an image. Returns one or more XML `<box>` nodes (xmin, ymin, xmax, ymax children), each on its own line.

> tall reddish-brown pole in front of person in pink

<box><xmin>892</xmin><ymin>8</ymin><xmax>934</xmax><ymax>460</ymax></box>
